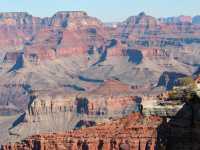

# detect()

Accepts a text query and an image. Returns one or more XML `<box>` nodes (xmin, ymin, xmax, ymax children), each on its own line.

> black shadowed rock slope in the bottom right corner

<box><xmin>160</xmin><ymin>103</ymin><xmax>200</xmax><ymax>150</ymax></box>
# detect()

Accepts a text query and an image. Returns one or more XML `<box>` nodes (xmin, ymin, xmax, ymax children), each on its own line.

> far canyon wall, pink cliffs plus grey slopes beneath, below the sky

<box><xmin>0</xmin><ymin>11</ymin><xmax>200</xmax><ymax>116</ymax></box>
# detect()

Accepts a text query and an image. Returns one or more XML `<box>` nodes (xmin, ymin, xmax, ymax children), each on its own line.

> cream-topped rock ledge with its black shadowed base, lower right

<box><xmin>143</xmin><ymin>95</ymin><xmax>200</xmax><ymax>150</ymax></box>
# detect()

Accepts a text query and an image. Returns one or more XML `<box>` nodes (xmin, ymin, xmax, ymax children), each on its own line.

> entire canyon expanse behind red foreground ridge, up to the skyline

<box><xmin>0</xmin><ymin>11</ymin><xmax>200</xmax><ymax>147</ymax></box>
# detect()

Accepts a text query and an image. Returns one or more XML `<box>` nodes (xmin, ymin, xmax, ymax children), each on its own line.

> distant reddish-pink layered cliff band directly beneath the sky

<box><xmin>0</xmin><ymin>11</ymin><xmax>200</xmax><ymax>61</ymax></box>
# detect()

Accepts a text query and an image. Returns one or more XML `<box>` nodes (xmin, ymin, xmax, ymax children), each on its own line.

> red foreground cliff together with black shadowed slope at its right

<box><xmin>2</xmin><ymin>100</ymin><xmax>200</xmax><ymax>150</ymax></box>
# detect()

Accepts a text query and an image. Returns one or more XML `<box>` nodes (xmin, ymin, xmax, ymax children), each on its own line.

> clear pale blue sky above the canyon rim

<box><xmin>0</xmin><ymin>0</ymin><xmax>200</xmax><ymax>22</ymax></box>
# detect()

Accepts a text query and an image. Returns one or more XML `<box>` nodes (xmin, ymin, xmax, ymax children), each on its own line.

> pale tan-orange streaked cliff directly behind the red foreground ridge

<box><xmin>2</xmin><ymin>79</ymin><xmax>144</xmax><ymax>144</ymax></box>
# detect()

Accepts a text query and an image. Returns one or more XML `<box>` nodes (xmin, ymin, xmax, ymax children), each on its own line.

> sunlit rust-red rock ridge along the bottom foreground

<box><xmin>2</xmin><ymin>113</ymin><xmax>162</xmax><ymax>150</ymax></box>
